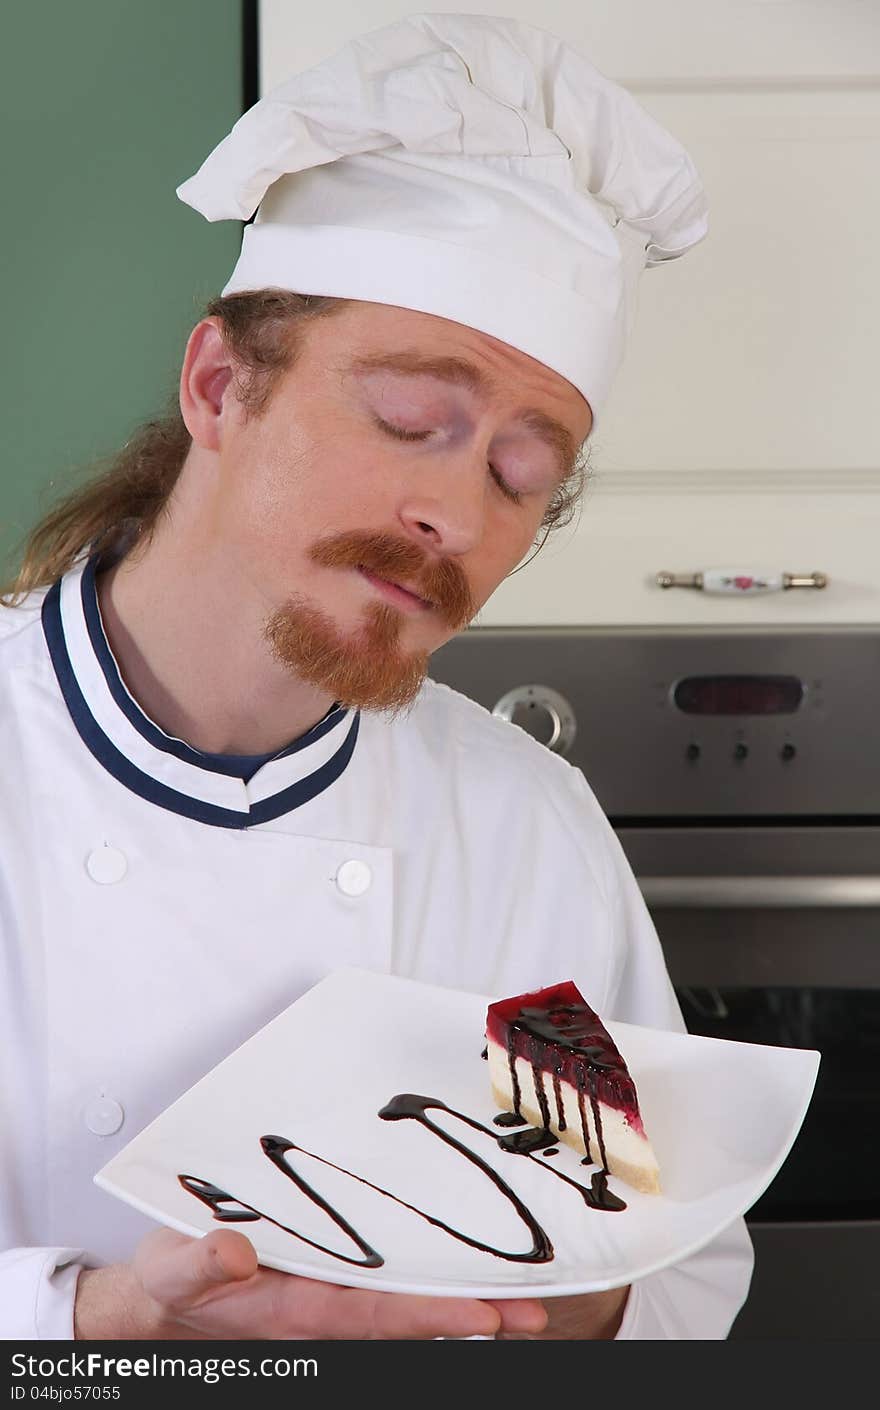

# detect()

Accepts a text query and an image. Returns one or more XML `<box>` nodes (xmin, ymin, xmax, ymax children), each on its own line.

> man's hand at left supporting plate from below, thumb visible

<box><xmin>73</xmin><ymin>1230</ymin><xmax>547</xmax><ymax>1341</ymax></box>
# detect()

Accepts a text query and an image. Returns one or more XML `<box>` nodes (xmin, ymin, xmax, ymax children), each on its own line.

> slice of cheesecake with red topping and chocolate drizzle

<box><xmin>487</xmin><ymin>980</ymin><xmax>660</xmax><ymax>1194</ymax></box>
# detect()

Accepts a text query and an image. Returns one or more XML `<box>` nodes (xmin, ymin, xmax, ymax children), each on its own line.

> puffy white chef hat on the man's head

<box><xmin>178</xmin><ymin>14</ymin><xmax>707</xmax><ymax>424</ymax></box>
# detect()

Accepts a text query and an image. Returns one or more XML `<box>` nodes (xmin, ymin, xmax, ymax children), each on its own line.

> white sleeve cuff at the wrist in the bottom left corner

<box><xmin>0</xmin><ymin>1248</ymin><xmax>85</xmax><ymax>1341</ymax></box>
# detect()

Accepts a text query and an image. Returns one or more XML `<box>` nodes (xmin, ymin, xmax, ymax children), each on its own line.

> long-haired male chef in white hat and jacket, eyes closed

<box><xmin>0</xmin><ymin>14</ymin><xmax>752</xmax><ymax>1340</ymax></box>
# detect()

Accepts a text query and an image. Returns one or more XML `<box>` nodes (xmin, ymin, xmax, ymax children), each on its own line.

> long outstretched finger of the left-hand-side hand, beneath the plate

<box><xmin>273</xmin><ymin>1277</ymin><xmax>501</xmax><ymax>1341</ymax></box>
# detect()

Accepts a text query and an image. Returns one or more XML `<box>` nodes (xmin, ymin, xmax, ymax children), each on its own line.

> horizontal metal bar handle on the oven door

<box><xmin>637</xmin><ymin>876</ymin><xmax>880</xmax><ymax>911</ymax></box>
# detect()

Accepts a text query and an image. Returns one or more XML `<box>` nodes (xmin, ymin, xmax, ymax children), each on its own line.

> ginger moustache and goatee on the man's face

<box><xmin>265</xmin><ymin>532</ymin><xmax>477</xmax><ymax>712</ymax></box>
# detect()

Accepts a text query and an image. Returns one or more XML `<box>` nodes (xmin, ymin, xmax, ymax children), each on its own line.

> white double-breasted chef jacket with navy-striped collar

<box><xmin>0</xmin><ymin>564</ymin><xmax>752</xmax><ymax>1340</ymax></box>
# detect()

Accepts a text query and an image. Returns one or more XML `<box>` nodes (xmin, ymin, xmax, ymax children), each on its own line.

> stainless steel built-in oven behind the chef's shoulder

<box><xmin>432</xmin><ymin>627</ymin><xmax>880</xmax><ymax>1340</ymax></box>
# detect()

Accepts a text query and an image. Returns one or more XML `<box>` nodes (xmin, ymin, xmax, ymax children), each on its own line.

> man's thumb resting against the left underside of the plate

<box><xmin>134</xmin><ymin>1230</ymin><xmax>258</xmax><ymax>1311</ymax></box>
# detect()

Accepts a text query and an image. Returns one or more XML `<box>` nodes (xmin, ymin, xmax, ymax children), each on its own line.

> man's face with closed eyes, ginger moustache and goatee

<box><xmin>213</xmin><ymin>303</ymin><xmax>591</xmax><ymax>708</ymax></box>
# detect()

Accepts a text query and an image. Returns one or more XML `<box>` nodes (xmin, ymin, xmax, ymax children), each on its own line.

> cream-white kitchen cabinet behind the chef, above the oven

<box><xmin>261</xmin><ymin>0</ymin><xmax>880</xmax><ymax>626</ymax></box>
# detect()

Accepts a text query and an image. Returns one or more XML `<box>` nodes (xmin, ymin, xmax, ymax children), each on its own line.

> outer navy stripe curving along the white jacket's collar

<box><xmin>42</xmin><ymin>581</ymin><xmax>360</xmax><ymax>830</ymax></box>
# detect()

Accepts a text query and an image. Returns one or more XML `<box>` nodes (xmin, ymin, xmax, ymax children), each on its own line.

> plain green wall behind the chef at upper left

<box><xmin>0</xmin><ymin>0</ymin><xmax>243</xmax><ymax>570</ymax></box>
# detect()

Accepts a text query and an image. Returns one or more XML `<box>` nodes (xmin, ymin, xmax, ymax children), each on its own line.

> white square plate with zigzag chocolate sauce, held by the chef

<box><xmin>94</xmin><ymin>969</ymin><xmax>819</xmax><ymax>1297</ymax></box>
